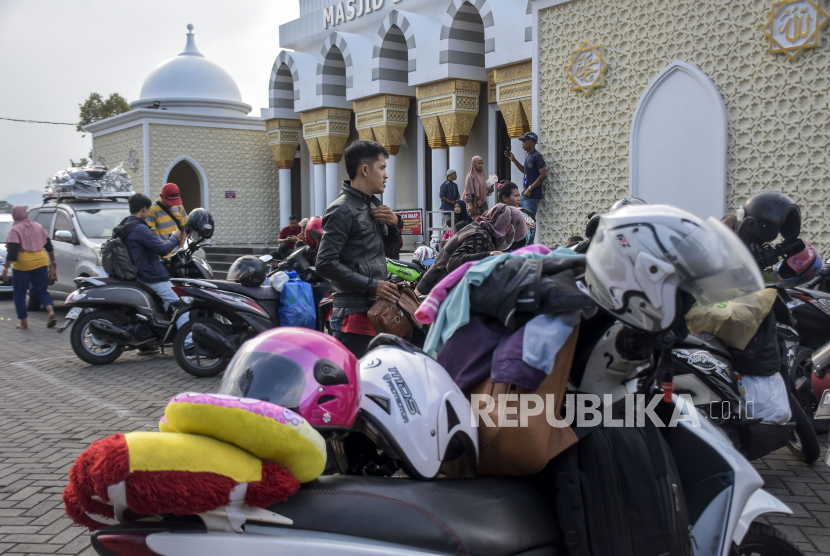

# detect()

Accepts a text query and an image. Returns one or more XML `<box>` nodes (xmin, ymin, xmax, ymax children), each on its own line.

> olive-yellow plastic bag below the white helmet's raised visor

<box><xmin>686</xmin><ymin>288</ymin><xmax>778</xmax><ymax>349</ymax></box>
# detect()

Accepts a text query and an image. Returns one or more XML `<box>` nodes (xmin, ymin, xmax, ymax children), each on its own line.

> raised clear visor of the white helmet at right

<box><xmin>657</xmin><ymin>217</ymin><xmax>764</xmax><ymax>305</ymax></box>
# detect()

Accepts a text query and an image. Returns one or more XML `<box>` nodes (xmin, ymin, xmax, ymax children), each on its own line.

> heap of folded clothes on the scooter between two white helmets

<box><xmin>415</xmin><ymin>245</ymin><xmax>595</xmax><ymax>391</ymax></box>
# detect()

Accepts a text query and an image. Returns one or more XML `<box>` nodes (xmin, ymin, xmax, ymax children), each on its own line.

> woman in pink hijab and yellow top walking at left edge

<box><xmin>3</xmin><ymin>206</ymin><xmax>57</xmax><ymax>329</ymax></box>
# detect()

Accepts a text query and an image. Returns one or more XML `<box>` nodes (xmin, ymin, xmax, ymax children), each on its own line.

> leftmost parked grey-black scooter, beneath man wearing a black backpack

<box><xmin>58</xmin><ymin>233</ymin><xmax>213</xmax><ymax>365</ymax></box>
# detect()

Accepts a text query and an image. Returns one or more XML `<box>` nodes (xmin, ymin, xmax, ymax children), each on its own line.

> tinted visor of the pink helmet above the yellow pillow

<box><xmin>219</xmin><ymin>349</ymin><xmax>305</xmax><ymax>409</ymax></box>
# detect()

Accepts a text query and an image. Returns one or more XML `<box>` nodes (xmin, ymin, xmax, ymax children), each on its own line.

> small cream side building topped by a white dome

<box><xmin>86</xmin><ymin>25</ymin><xmax>278</xmax><ymax>245</ymax></box>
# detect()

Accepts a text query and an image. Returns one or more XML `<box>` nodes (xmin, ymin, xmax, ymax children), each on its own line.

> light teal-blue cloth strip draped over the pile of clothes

<box><xmin>424</xmin><ymin>247</ymin><xmax>585</xmax><ymax>359</ymax></box>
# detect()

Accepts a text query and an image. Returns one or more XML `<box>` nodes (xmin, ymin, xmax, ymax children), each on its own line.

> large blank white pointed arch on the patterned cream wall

<box><xmin>629</xmin><ymin>60</ymin><xmax>727</xmax><ymax>219</ymax></box>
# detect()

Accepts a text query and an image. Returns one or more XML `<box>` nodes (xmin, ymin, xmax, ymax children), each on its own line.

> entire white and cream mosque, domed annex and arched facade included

<box><xmin>88</xmin><ymin>0</ymin><xmax>830</xmax><ymax>252</ymax></box>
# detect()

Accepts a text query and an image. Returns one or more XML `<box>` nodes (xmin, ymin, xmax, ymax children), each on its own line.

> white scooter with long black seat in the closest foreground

<box><xmin>83</xmin><ymin>334</ymin><xmax>801</xmax><ymax>556</ymax></box>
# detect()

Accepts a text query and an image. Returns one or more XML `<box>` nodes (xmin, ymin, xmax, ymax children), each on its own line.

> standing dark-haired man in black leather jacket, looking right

<box><xmin>317</xmin><ymin>141</ymin><xmax>403</xmax><ymax>357</ymax></box>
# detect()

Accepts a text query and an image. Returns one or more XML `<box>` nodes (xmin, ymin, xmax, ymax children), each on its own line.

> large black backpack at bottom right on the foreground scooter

<box><xmin>546</xmin><ymin>402</ymin><xmax>692</xmax><ymax>556</ymax></box>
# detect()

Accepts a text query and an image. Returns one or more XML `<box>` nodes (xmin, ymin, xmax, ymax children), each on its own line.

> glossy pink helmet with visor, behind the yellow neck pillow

<box><xmin>219</xmin><ymin>327</ymin><xmax>360</xmax><ymax>436</ymax></box>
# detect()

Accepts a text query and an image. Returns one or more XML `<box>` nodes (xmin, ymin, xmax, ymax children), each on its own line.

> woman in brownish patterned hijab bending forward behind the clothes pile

<box><xmin>417</xmin><ymin>204</ymin><xmax>527</xmax><ymax>295</ymax></box>
